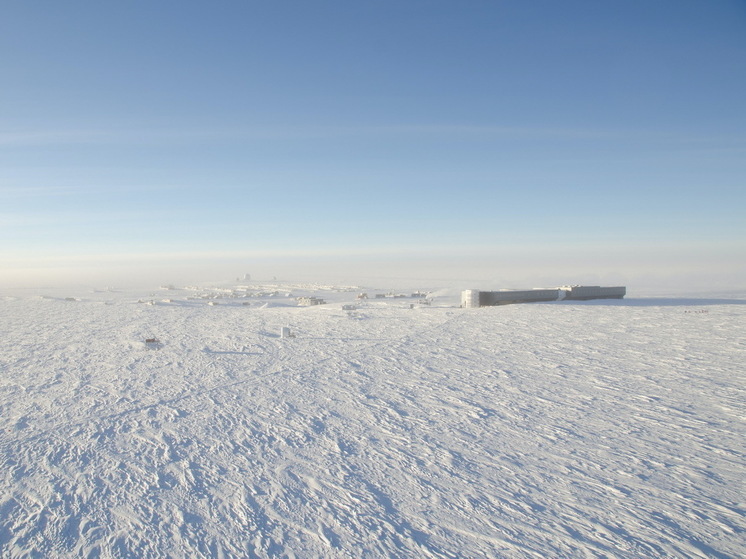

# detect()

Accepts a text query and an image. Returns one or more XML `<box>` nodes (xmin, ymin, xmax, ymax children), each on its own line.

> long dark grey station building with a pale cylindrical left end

<box><xmin>461</xmin><ymin>285</ymin><xmax>627</xmax><ymax>308</ymax></box>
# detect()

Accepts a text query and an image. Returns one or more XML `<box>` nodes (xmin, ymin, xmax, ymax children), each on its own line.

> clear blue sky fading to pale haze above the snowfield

<box><xmin>0</xmin><ymin>0</ymin><xmax>746</xmax><ymax>292</ymax></box>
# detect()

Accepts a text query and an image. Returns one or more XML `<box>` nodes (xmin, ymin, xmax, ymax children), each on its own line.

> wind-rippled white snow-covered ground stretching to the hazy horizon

<box><xmin>0</xmin><ymin>283</ymin><xmax>746</xmax><ymax>558</ymax></box>
